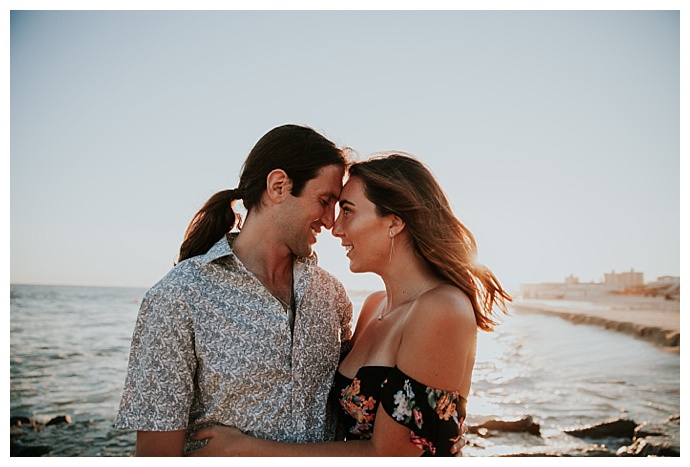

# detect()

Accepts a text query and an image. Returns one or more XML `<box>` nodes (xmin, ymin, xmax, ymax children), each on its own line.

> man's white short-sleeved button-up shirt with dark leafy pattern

<box><xmin>115</xmin><ymin>235</ymin><xmax>352</xmax><ymax>447</ymax></box>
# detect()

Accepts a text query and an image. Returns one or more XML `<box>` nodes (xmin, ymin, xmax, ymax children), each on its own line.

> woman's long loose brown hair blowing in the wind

<box><xmin>348</xmin><ymin>153</ymin><xmax>512</xmax><ymax>331</ymax></box>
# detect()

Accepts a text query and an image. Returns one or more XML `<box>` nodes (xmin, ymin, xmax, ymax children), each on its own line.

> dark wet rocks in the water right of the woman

<box><xmin>466</xmin><ymin>414</ymin><xmax>680</xmax><ymax>457</ymax></box>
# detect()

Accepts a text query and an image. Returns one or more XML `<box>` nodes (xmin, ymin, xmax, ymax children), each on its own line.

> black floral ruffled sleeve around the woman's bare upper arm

<box><xmin>380</xmin><ymin>367</ymin><xmax>467</xmax><ymax>456</ymax></box>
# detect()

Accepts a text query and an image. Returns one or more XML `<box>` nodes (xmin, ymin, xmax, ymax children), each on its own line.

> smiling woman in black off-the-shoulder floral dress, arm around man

<box><xmin>188</xmin><ymin>154</ymin><xmax>511</xmax><ymax>456</ymax></box>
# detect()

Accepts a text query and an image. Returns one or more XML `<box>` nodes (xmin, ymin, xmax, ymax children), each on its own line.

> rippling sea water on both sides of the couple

<box><xmin>10</xmin><ymin>285</ymin><xmax>680</xmax><ymax>457</ymax></box>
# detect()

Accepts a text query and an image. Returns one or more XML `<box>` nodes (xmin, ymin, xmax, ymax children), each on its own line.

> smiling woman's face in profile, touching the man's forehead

<box><xmin>333</xmin><ymin>177</ymin><xmax>391</xmax><ymax>273</ymax></box>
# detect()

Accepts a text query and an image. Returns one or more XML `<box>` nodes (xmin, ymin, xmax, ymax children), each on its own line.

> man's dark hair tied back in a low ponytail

<box><xmin>178</xmin><ymin>125</ymin><xmax>347</xmax><ymax>262</ymax></box>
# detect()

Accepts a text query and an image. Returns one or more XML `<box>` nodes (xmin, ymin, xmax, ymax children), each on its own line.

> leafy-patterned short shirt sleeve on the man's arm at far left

<box><xmin>115</xmin><ymin>290</ymin><xmax>196</xmax><ymax>431</ymax></box>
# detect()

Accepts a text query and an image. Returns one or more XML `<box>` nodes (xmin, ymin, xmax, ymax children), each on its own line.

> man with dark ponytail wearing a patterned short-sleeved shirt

<box><xmin>115</xmin><ymin>125</ymin><xmax>352</xmax><ymax>456</ymax></box>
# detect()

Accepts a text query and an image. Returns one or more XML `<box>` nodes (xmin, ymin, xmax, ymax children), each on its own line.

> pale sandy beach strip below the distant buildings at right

<box><xmin>512</xmin><ymin>294</ymin><xmax>680</xmax><ymax>352</ymax></box>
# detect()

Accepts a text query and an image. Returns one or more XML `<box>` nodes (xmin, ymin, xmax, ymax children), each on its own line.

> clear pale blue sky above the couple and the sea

<box><xmin>5</xmin><ymin>1</ymin><xmax>681</xmax><ymax>296</ymax></box>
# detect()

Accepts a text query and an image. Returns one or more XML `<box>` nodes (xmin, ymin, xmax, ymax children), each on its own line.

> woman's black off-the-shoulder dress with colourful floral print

<box><xmin>331</xmin><ymin>366</ymin><xmax>467</xmax><ymax>456</ymax></box>
